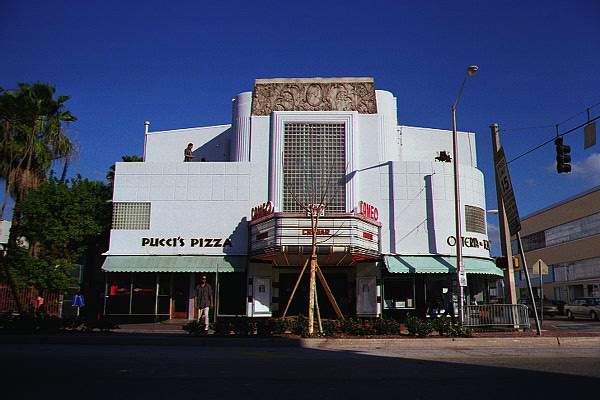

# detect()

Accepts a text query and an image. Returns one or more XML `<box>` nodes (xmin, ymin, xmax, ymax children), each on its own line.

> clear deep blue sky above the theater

<box><xmin>0</xmin><ymin>0</ymin><xmax>600</xmax><ymax>254</ymax></box>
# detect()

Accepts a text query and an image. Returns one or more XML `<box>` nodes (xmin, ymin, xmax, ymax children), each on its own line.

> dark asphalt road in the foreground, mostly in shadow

<box><xmin>0</xmin><ymin>344</ymin><xmax>600</xmax><ymax>400</ymax></box>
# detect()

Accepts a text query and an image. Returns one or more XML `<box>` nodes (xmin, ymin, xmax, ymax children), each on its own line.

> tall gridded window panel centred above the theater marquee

<box><xmin>283</xmin><ymin>123</ymin><xmax>346</xmax><ymax>213</ymax></box>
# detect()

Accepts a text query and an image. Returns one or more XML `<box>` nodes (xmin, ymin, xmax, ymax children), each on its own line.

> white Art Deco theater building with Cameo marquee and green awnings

<box><xmin>102</xmin><ymin>78</ymin><xmax>502</xmax><ymax>320</ymax></box>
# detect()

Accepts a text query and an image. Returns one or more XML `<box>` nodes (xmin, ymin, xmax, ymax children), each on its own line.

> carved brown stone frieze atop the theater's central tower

<box><xmin>252</xmin><ymin>78</ymin><xmax>377</xmax><ymax>115</ymax></box>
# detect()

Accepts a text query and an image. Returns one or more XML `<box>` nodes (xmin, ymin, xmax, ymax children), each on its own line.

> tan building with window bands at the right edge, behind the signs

<box><xmin>512</xmin><ymin>186</ymin><xmax>600</xmax><ymax>302</ymax></box>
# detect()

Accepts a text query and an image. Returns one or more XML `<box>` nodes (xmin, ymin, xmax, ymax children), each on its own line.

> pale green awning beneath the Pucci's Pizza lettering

<box><xmin>102</xmin><ymin>255</ymin><xmax>248</xmax><ymax>272</ymax></box>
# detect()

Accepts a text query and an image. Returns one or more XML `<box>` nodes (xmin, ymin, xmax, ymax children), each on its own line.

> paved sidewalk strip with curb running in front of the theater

<box><xmin>0</xmin><ymin>320</ymin><xmax>600</xmax><ymax>349</ymax></box>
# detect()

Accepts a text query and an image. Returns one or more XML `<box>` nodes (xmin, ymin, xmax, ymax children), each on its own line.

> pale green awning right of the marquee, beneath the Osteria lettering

<box><xmin>384</xmin><ymin>255</ymin><xmax>504</xmax><ymax>276</ymax></box>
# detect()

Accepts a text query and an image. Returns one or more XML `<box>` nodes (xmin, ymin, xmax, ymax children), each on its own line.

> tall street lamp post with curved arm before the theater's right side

<box><xmin>452</xmin><ymin>65</ymin><xmax>479</xmax><ymax>324</ymax></box>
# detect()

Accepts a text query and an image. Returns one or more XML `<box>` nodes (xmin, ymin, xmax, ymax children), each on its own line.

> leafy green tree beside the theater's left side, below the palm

<box><xmin>6</xmin><ymin>174</ymin><xmax>112</xmax><ymax>290</ymax></box>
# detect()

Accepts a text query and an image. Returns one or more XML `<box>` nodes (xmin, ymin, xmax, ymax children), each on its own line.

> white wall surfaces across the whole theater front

<box><xmin>109</xmin><ymin>86</ymin><xmax>489</xmax><ymax>257</ymax></box>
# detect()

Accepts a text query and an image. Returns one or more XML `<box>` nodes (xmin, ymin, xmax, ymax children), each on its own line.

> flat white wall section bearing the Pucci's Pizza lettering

<box><xmin>109</xmin><ymin>162</ymin><xmax>253</xmax><ymax>254</ymax></box>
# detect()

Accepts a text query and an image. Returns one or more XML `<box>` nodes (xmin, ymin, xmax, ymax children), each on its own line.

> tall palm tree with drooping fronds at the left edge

<box><xmin>0</xmin><ymin>82</ymin><xmax>77</xmax><ymax>312</ymax></box>
